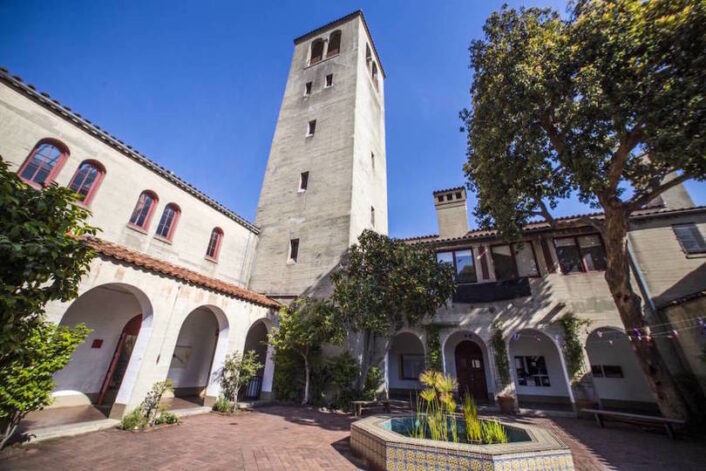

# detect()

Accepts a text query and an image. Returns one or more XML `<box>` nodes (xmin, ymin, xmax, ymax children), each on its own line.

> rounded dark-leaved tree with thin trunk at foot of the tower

<box><xmin>331</xmin><ymin>230</ymin><xmax>456</xmax><ymax>388</ymax></box>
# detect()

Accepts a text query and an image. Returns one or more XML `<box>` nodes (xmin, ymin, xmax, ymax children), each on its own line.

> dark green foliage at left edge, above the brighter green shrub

<box><xmin>0</xmin><ymin>157</ymin><xmax>97</xmax><ymax>366</ymax></box>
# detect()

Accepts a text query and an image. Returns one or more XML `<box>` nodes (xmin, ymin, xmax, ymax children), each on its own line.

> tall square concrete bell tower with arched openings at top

<box><xmin>250</xmin><ymin>11</ymin><xmax>387</xmax><ymax>301</ymax></box>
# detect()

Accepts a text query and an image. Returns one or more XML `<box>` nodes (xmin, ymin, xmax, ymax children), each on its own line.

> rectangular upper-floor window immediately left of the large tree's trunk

<box><xmin>554</xmin><ymin>234</ymin><xmax>606</xmax><ymax>274</ymax></box>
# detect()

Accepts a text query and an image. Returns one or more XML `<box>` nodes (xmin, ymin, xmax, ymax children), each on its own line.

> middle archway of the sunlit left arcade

<box><xmin>167</xmin><ymin>306</ymin><xmax>228</xmax><ymax>409</ymax></box>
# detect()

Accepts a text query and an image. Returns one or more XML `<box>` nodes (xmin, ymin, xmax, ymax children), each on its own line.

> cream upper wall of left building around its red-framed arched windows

<box><xmin>0</xmin><ymin>83</ymin><xmax>257</xmax><ymax>286</ymax></box>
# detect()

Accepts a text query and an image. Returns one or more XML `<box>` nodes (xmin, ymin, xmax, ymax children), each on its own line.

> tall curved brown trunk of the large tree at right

<box><xmin>603</xmin><ymin>206</ymin><xmax>688</xmax><ymax>419</ymax></box>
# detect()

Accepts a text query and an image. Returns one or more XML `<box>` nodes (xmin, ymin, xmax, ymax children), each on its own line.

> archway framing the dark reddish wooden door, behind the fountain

<box><xmin>444</xmin><ymin>330</ymin><xmax>495</xmax><ymax>402</ymax></box>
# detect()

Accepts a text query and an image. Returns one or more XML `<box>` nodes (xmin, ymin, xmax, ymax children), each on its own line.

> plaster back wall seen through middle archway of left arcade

<box><xmin>167</xmin><ymin>308</ymin><xmax>219</xmax><ymax>388</ymax></box>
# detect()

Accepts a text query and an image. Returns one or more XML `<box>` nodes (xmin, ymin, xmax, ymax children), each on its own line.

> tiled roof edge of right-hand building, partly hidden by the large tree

<box><xmin>399</xmin><ymin>206</ymin><xmax>706</xmax><ymax>244</ymax></box>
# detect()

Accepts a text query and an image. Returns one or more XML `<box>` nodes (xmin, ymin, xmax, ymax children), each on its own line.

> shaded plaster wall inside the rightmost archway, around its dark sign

<box><xmin>586</xmin><ymin>330</ymin><xmax>654</xmax><ymax>402</ymax></box>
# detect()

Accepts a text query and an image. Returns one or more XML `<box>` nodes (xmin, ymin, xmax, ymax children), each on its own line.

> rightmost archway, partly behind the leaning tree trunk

<box><xmin>586</xmin><ymin>327</ymin><xmax>659</xmax><ymax>412</ymax></box>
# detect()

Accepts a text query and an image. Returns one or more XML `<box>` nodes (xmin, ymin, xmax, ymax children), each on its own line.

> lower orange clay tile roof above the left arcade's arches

<box><xmin>83</xmin><ymin>237</ymin><xmax>280</xmax><ymax>308</ymax></box>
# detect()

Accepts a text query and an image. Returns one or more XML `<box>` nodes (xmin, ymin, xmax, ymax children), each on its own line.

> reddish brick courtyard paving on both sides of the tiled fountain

<box><xmin>0</xmin><ymin>406</ymin><xmax>706</xmax><ymax>471</ymax></box>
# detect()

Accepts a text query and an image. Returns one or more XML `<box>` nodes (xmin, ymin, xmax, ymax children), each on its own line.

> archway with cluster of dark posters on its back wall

<box><xmin>508</xmin><ymin>329</ymin><xmax>573</xmax><ymax>409</ymax></box>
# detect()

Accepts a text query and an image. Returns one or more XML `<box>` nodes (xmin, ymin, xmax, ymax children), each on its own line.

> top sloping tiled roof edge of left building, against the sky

<box><xmin>0</xmin><ymin>67</ymin><xmax>260</xmax><ymax>234</ymax></box>
